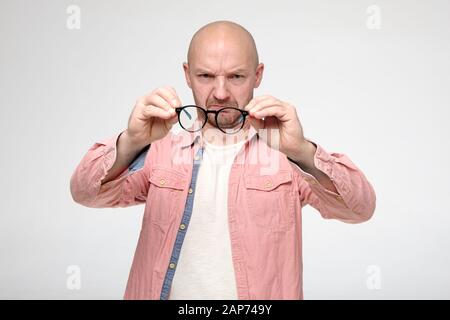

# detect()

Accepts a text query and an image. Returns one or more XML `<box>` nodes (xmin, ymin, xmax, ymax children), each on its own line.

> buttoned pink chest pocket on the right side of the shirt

<box><xmin>244</xmin><ymin>171</ymin><xmax>294</xmax><ymax>231</ymax></box>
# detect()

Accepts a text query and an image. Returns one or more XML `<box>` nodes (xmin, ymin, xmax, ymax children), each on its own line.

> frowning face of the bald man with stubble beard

<box><xmin>183</xmin><ymin>38</ymin><xmax>264</xmax><ymax>132</ymax></box>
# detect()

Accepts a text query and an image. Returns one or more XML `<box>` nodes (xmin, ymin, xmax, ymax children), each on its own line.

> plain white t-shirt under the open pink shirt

<box><xmin>169</xmin><ymin>140</ymin><xmax>245</xmax><ymax>300</ymax></box>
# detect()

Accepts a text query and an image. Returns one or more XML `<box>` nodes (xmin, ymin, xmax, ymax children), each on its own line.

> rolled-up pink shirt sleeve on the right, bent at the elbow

<box><xmin>291</xmin><ymin>142</ymin><xmax>376</xmax><ymax>223</ymax></box>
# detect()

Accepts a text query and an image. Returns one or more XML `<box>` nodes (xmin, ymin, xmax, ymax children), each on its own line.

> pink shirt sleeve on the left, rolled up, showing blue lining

<box><xmin>70</xmin><ymin>131</ymin><xmax>150</xmax><ymax>208</ymax></box>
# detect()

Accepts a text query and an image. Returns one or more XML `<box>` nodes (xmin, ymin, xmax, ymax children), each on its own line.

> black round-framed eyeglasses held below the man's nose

<box><xmin>175</xmin><ymin>105</ymin><xmax>248</xmax><ymax>134</ymax></box>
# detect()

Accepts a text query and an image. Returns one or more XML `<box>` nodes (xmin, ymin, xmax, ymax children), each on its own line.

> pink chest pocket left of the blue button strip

<box><xmin>144</xmin><ymin>166</ymin><xmax>186</xmax><ymax>224</ymax></box>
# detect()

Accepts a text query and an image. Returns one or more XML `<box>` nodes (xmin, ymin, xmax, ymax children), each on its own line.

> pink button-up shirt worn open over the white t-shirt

<box><xmin>70</xmin><ymin>131</ymin><xmax>376</xmax><ymax>299</ymax></box>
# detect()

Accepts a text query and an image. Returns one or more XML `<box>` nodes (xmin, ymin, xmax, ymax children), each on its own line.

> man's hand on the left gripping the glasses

<box><xmin>126</xmin><ymin>87</ymin><xmax>181</xmax><ymax>148</ymax></box>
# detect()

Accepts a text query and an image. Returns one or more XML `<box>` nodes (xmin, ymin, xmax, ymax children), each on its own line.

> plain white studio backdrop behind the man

<box><xmin>0</xmin><ymin>0</ymin><xmax>450</xmax><ymax>299</ymax></box>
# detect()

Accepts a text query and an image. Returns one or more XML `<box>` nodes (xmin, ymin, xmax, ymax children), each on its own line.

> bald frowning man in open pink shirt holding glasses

<box><xmin>71</xmin><ymin>21</ymin><xmax>375</xmax><ymax>300</ymax></box>
